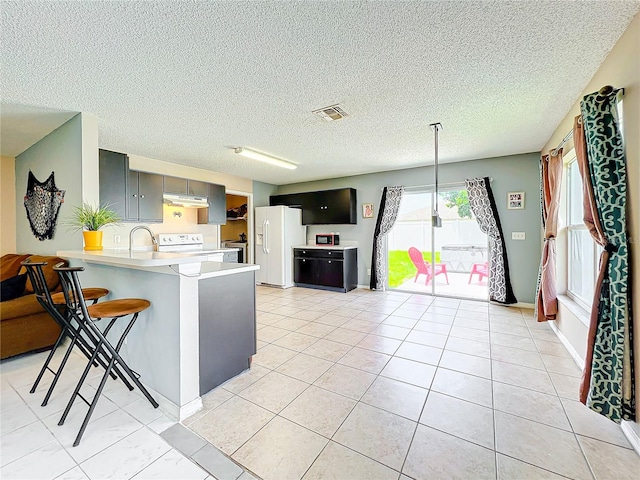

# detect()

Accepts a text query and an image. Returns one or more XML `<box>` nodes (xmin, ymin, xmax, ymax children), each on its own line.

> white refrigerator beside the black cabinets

<box><xmin>254</xmin><ymin>206</ymin><xmax>307</xmax><ymax>288</ymax></box>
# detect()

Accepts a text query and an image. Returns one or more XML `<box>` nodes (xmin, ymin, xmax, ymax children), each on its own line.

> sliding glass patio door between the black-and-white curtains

<box><xmin>387</xmin><ymin>184</ymin><xmax>489</xmax><ymax>300</ymax></box>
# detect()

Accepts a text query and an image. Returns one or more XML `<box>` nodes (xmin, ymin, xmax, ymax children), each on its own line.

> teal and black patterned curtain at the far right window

<box><xmin>574</xmin><ymin>87</ymin><xmax>635</xmax><ymax>423</ymax></box>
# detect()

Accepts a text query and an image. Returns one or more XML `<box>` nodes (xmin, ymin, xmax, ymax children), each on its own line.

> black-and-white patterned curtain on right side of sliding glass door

<box><xmin>465</xmin><ymin>177</ymin><xmax>517</xmax><ymax>304</ymax></box>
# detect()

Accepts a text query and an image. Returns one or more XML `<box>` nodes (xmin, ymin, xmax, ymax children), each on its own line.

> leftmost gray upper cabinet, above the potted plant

<box><xmin>99</xmin><ymin>150</ymin><xmax>129</xmax><ymax>220</ymax></box>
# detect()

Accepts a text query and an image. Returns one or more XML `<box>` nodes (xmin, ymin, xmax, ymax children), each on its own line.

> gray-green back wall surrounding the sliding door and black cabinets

<box><xmin>278</xmin><ymin>153</ymin><xmax>541</xmax><ymax>303</ymax></box>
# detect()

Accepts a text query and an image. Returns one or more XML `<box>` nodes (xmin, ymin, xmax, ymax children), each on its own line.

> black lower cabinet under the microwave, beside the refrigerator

<box><xmin>293</xmin><ymin>248</ymin><xmax>358</xmax><ymax>292</ymax></box>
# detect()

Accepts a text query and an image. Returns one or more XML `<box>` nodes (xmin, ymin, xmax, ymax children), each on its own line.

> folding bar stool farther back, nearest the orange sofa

<box><xmin>21</xmin><ymin>260</ymin><xmax>112</xmax><ymax>407</ymax></box>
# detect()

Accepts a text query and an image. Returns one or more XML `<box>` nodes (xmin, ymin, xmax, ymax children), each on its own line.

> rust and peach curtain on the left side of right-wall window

<box><xmin>536</xmin><ymin>148</ymin><xmax>562</xmax><ymax>322</ymax></box>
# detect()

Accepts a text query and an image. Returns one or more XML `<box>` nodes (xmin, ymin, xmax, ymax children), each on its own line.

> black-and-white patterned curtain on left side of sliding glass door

<box><xmin>369</xmin><ymin>186</ymin><xmax>404</xmax><ymax>290</ymax></box>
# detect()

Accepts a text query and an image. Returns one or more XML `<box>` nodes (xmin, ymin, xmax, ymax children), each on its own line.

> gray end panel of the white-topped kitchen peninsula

<box><xmin>198</xmin><ymin>271</ymin><xmax>257</xmax><ymax>395</ymax></box>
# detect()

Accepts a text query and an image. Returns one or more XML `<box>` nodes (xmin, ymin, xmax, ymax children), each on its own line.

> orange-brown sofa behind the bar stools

<box><xmin>0</xmin><ymin>254</ymin><xmax>67</xmax><ymax>359</ymax></box>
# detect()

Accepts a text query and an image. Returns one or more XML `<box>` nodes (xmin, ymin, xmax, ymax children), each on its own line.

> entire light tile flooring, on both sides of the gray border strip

<box><xmin>0</xmin><ymin>287</ymin><xmax>640</xmax><ymax>480</ymax></box>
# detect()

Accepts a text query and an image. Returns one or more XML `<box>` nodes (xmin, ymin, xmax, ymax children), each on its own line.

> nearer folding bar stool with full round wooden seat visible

<box><xmin>53</xmin><ymin>264</ymin><xmax>158</xmax><ymax>447</ymax></box>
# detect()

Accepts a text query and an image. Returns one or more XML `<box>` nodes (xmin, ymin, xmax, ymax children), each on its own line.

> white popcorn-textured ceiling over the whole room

<box><xmin>0</xmin><ymin>0</ymin><xmax>640</xmax><ymax>184</ymax></box>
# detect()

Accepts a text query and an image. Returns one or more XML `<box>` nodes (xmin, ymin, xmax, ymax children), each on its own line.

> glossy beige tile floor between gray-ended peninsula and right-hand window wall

<box><xmin>184</xmin><ymin>287</ymin><xmax>640</xmax><ymax>480</ymax></box>
